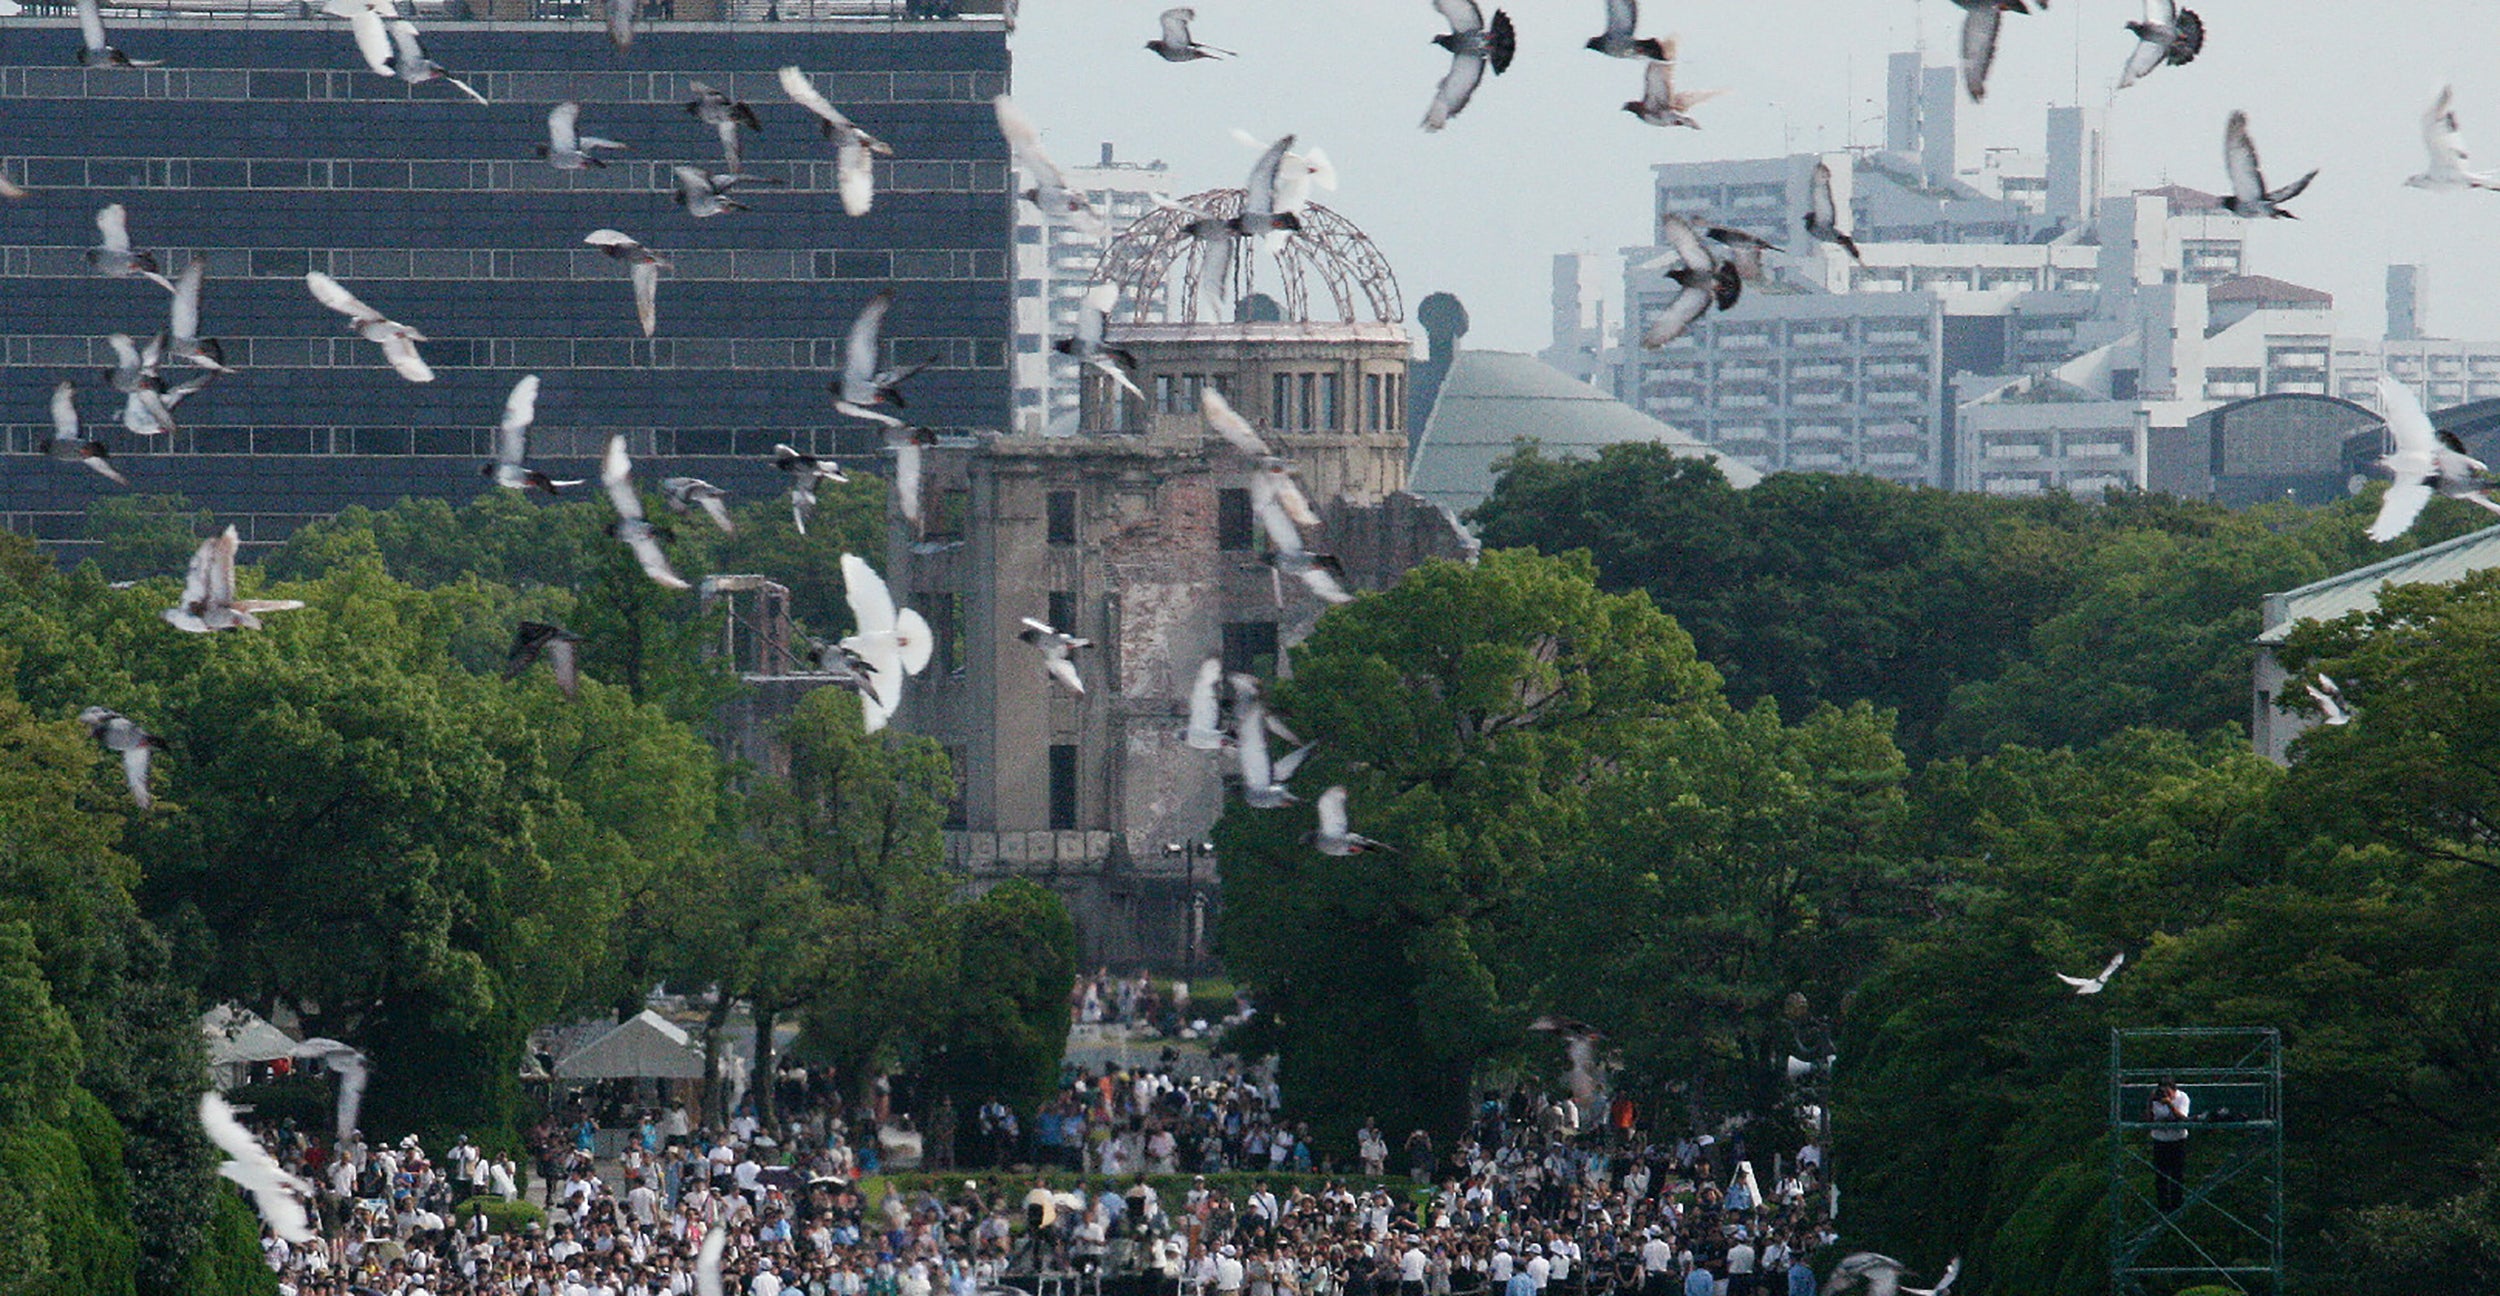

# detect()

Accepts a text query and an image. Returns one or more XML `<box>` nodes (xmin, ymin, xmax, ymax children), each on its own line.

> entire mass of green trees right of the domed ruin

<box><xmin>1218</xmin><ymin>448</ymin><xmax>2500</xmax><ymax>1296</ymax></box>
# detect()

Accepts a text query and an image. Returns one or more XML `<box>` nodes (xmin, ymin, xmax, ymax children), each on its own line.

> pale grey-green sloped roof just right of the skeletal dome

<box><xmin>1408</xmin><ymin>350</ymin><xmax>1763</xmax><ymax>513</ymax></box>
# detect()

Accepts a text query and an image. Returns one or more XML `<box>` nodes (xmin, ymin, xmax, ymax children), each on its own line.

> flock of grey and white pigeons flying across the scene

<box><xmin>44</xmin><ymin>0</ymin><xmax>2500</xmax><ymax>1296</ymax></box>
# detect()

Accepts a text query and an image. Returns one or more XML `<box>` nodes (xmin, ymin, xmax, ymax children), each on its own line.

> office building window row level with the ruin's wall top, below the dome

<box><xmin>0</xmin><ymin>425</ymin><xmax>900</xmax><ymax>460</ymax></box>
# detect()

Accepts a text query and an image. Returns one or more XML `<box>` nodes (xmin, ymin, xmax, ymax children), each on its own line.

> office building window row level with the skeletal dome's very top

<box><xmin>0</xmin><ymin>158</ymin><xmax>1008</xmax><ymax>203</ymax></box>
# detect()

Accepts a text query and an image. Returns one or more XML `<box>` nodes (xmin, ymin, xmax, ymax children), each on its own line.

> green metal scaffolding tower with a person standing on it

<box><xmin>2110</xmin><ymin>1028</ymin><xmax>2283</xmax><ymax>1296</ymax></box>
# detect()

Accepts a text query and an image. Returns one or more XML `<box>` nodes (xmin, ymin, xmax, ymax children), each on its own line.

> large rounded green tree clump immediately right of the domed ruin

<box><xmin>1215</xmin><ymin>550</ymin><xmax>1903</xmax><ymax>1136</ymax></box>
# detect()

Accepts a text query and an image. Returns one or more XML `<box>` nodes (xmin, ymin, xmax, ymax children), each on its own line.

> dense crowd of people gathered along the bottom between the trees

<box><xmin>235</xmin><ymin>1066</ymin><xmax>1833</xmax><ymax>1296</ymax></box>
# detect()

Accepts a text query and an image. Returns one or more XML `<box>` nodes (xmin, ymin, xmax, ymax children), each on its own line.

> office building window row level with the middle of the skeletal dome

<box><xmin>0</xmin><ymin>245</ymin><xmax>1008</xmax><ymax>283</ymax></box>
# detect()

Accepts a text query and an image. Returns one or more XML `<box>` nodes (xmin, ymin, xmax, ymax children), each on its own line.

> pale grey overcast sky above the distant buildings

<box><xmin>1015</xmin><ymin>0</ymin><xmax>2500</xmax><ymax>350</ymax></box>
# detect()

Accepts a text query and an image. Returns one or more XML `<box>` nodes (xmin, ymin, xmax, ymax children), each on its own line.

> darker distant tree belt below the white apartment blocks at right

<box><xmin>1473</xmin><ymin>443</ymin><xmax>2488</xmax><ymax>758</ymax></box>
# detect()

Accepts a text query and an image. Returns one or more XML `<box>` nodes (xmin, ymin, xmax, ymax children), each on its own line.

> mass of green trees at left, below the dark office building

<box><xmin>0</xmin><ymin>480</ymin><xmax>1075</xmax><ymax>1296</ymax></box>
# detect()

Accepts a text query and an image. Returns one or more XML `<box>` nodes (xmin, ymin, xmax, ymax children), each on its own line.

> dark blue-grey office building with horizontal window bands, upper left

<box><xmin>0</xmin><ymin>0</ymin><xmax>1013</xmax><ymax>553</ymax></box>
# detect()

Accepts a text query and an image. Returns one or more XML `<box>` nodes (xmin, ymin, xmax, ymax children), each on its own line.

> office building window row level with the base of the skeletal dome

<box><xmin>0</xmin><ymin>335</ymin><xmax>1008</xmax><ymax>370</ymax></box>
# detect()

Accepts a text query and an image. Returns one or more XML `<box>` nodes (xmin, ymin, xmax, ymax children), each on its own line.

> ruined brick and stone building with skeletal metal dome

<box><xmin>888</xmin><ymin>193</ymin><xmax>1475</xmax><ymax>971</ymax></box>
